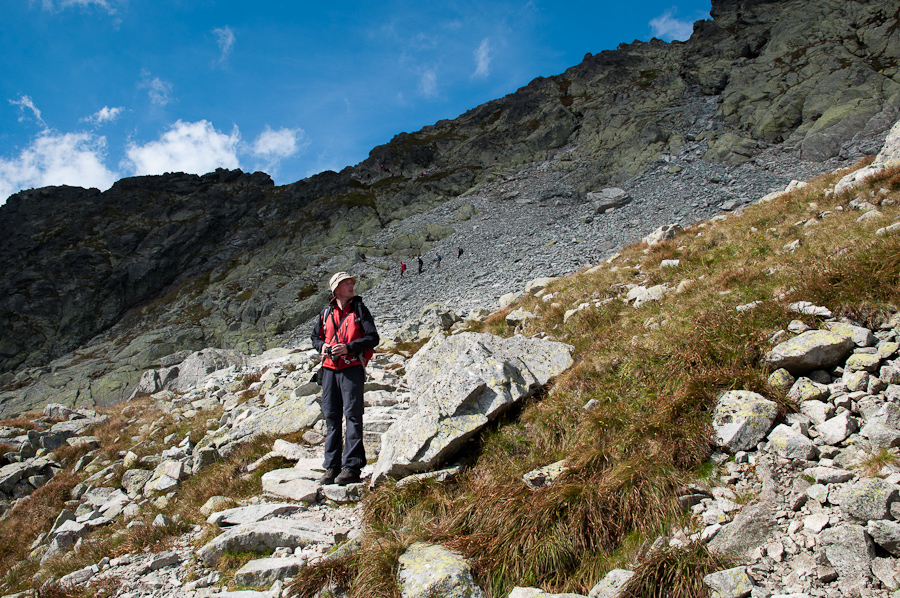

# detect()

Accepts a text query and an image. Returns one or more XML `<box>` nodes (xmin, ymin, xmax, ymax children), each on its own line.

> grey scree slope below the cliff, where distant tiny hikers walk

<box><xmin>302</xmin><ymin>135</ymin><xmax>847</xmax><ymax>345</ymax></box>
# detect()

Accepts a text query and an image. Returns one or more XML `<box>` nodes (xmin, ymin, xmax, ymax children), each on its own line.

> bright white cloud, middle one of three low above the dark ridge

<box><xmin>125</xmin><ymin>120</ymin><xmax>241</xmax><ymax>175</ymax></box>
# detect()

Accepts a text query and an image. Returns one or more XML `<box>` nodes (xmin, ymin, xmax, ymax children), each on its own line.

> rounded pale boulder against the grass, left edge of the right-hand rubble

<box><xmin>713</xmin><ymin>390</ymin><xmax>778</xmax><ymax>454</ymax></box>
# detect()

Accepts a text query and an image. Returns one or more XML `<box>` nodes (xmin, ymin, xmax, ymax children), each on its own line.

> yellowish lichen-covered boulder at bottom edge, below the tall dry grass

<box><xmin>397</xmin><ymin>542</ymin><xmax>484</xmax><ymax>598</ymax></box>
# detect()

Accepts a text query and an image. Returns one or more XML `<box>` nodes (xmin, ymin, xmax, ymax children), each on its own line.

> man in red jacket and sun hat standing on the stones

<box><xmin>310</xmin><ymin>272</ymin><xmax>380</xmax><ymax>486</ymax></box>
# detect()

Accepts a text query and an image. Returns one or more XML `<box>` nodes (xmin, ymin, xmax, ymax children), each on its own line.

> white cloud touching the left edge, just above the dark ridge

<box><xmin>0</xmin><ymin>130</ymin><xmax>118</xmax><ymax>203</ymax></box>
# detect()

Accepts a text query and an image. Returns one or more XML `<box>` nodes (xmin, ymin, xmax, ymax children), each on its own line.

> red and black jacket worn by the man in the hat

<box><xmin>311</xmin><ymin>296</ymin><xmax>380</xmax><ymax>370</ymax></box>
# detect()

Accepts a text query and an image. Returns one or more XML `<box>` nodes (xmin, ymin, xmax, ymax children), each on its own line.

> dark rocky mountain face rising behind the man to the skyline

<box><xmin>0</xmin><ymin>0</ymin><xmax>900</xmax><ymax>414</ymax></box>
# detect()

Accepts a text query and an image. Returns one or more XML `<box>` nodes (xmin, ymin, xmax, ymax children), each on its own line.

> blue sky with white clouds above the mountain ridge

<box><xmin>0</xmin><ymin>0</ymin><xmax>710</xmax><ymax>204</ymax></box>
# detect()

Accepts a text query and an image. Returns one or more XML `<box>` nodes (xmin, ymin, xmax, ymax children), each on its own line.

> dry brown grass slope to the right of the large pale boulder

<box><xmin>306</xmin><ymin>161</ymin><xmax>900</xmax><ymax>597</ymax></box>
